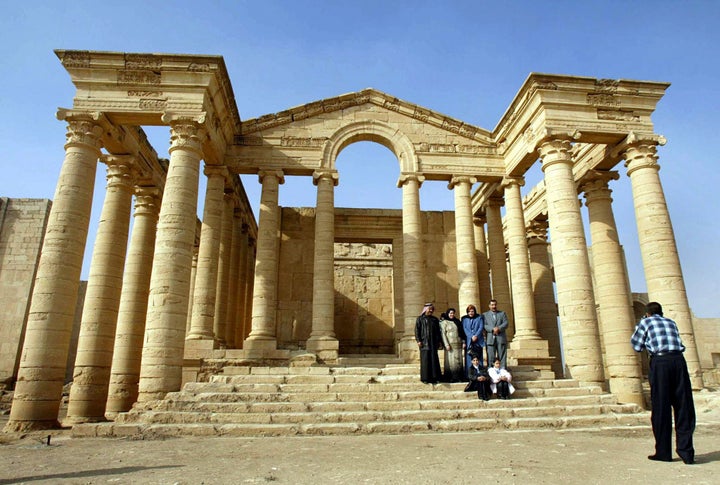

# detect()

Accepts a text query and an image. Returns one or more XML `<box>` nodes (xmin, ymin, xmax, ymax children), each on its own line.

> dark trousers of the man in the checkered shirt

<box><xmin>650</xmin><ymin>353</ymin><xmax>695</xmax><ymax>461</ymax></box>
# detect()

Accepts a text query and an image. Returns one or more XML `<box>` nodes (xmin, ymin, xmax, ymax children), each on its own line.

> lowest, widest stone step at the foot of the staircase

<box><xmin>72</xmin><ymin>413</ymin><xmax>648</xmax><ymax>439</ymax></box>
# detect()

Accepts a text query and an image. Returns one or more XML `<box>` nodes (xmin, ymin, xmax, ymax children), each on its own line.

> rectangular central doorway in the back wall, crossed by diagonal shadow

<box><xmin>335</xmin><ymin>242</ymin><xmax>395</xmax><ymax>355</ymax></box>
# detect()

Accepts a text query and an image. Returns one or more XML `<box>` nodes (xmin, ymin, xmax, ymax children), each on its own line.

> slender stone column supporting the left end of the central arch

<box><xmin>307</xmin><ymin>171</ymin><xmax>339</xmax><ymax>361</ymax></box>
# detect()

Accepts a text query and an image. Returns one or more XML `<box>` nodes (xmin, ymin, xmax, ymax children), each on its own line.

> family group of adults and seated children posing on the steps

<box><xmin>415</xmin><ymin>299</ymin><xmax>515</xmax><ymax>401</ymax></box>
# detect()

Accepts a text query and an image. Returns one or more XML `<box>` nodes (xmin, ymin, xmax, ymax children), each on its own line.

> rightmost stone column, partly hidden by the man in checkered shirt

<box><xmin>624</xmin><ymin>141</ymin><xmax>703</xmax><ymax>389</ymax></box>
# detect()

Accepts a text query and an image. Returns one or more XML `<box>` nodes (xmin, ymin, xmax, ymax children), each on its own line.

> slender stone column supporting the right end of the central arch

<box><xmin>398</xmin><ymin>173</ymin><xmax>425</xmax><ymax>359</ymax></box>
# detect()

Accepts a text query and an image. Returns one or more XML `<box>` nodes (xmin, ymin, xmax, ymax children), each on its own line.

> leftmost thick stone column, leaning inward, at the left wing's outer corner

<box><xmin>5</xmin><ymin>120</ymin><xmax>103</xmax><ymax>431</ymax></box>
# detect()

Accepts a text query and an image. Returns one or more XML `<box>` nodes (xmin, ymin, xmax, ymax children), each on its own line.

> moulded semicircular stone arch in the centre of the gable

<box><xmin>321</xmin><ymin>119</ymin><xmax>418</xmax><ymax>173</ymax></box>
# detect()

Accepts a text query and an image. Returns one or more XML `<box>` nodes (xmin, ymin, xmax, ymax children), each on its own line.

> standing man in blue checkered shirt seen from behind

<box><xmin>630</xmin><ymin>302</ymin><xmax>695</xmax><ymax>465</ymax></box>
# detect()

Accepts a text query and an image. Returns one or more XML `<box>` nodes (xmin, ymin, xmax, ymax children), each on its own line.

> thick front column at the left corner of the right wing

<box><xmin>539</xmin><ymin>139</ymin><xmax>605</xmax><ymax>383</ymax></box>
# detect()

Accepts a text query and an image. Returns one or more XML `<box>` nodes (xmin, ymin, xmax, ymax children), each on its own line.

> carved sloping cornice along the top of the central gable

<box><xmin>241</xmin><ymin>88</ymin><xmax>492</xmax><ymax>144</ymax></box>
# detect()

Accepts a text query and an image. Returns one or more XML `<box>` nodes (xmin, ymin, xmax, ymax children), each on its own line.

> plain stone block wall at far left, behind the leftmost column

<box><xmin>0</xmin><ymin>197</ymin><xmax>52</xmax><ymax>385</ymax></box>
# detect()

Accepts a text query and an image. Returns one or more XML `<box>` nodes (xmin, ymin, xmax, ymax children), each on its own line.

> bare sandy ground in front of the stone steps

<box><xmin>0</xmin><ymin>415</ymin><xmax>720</xmax><ymax>485</ymax></box>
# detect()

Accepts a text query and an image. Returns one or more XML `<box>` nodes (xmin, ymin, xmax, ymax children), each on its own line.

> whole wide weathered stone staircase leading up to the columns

<box><xmin>73</xmin><ymin>358</ymin><xmax>648</xmax><ymax>439</ymax></box>
